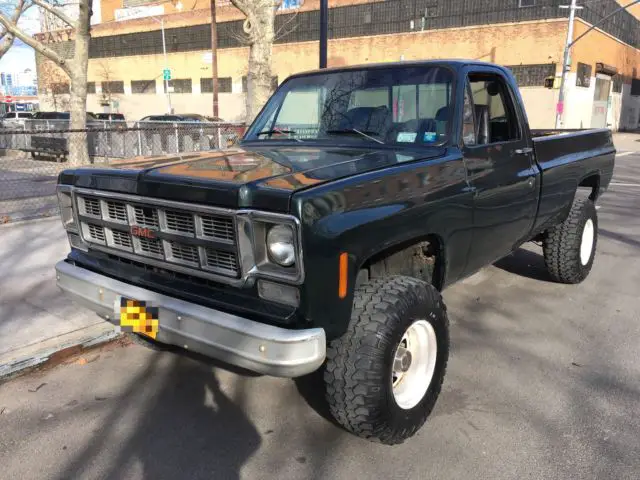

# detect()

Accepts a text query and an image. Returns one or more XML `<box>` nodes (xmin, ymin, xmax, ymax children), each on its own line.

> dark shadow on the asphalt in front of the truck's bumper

<box><xmin>59</xmin><ymin>353</ymin><xmax>261</xmax><ymax>479</ymax></box>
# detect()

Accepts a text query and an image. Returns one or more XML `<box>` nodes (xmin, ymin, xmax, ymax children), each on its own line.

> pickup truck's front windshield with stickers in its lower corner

<box><xmin>246</xmin><ymin>66</ymin><xmax>453</xmax><ymax>145</ymax></box>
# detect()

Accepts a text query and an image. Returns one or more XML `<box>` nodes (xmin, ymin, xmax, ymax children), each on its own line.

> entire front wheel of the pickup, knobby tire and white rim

<box><xmin>324</xmin><ymin>276</ymin><xmax>449</xmax><ymax>445</ymax></box>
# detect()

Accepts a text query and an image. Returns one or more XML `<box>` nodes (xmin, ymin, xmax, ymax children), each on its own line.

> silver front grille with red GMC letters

<box><xmin>76</xmin><ymin>192</ymin><xmax>240</xmax><ymax>278</ymax></box>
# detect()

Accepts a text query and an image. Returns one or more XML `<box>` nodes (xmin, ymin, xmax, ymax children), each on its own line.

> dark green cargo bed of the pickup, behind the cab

<box><xmin>531</xmin><ymin>129</ymin><xmax>616</xmax><ymax>232</ymax></box>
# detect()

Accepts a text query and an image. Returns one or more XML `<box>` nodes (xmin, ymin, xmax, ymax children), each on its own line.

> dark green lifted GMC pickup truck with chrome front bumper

<box><xmin>56</xmin><ymin>61</ymin><xmax>615</xmax><ymax>444</ymax></box>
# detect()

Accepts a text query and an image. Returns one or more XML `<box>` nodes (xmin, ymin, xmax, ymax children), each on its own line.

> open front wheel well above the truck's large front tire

<box><xmin>356</xmin><ymin>235</ymin><xmax>444</xmax><ymax>290</ymax></box>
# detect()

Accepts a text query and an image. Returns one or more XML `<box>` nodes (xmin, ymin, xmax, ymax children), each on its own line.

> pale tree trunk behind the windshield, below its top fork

<box><xmin>245</xmin><ymin>7</ymin><xmax>276</xmax><ymax>125</ymax></box>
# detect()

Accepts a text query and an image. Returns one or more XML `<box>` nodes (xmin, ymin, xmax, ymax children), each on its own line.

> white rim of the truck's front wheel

<box><xmin>391</xmin><ymin>320</ymin><xmax>438</xmax><ymax>410</ymax></box>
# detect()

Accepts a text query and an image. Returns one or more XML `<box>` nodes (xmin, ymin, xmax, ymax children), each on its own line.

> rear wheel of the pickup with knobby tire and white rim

<box><xmin>543</xmin><ymin>198</ymin><xmax>598</xmax><ymax>284</ymax></box>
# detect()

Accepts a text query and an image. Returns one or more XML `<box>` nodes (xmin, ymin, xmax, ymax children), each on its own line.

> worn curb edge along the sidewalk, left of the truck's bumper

<box><xmin>0</xmin><ymin>322</ymin><xmax>121</xmax><ymax>382</ymax></box>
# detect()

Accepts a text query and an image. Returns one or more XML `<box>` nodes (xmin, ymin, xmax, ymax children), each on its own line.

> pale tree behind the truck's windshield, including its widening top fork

<box><xmin>231</xmin><ymin>0</ymin><xmax>281</xmax><ymax>123</ymax></box>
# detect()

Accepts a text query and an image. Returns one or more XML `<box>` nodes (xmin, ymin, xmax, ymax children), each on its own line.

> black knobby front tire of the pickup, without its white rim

<box><xmin>324</xmin><ymin>276</ymin><xmax>449</xmax><ymax>444</ymax></box>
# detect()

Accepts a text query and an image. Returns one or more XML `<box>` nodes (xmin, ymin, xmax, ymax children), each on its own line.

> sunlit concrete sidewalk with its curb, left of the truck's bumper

<box><xmin>0</xmin><ymin>217</ymin><xmax>116</xmax><ymax>378</ymax></box>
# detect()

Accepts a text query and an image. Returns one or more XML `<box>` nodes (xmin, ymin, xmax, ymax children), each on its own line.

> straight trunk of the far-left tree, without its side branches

<box><xmin>69</xmin><ymin>0</ymin><xmax>91</xmax><ymax>165</ymax></box>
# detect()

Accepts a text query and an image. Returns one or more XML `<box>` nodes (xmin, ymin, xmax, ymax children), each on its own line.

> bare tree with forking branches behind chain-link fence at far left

<box><xmin>0</xmin><ymin>0</ymin><xmax>92</xmax><ymax>165</ymax></box>
